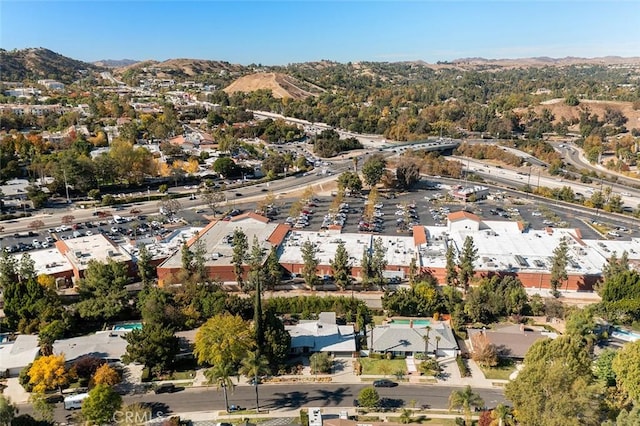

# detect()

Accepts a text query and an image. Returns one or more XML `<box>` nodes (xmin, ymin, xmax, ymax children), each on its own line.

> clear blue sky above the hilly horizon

<box><xmin>0</xmin><ymin>0</ymin><xmax>640</xmax><ymax>65</ymax></box>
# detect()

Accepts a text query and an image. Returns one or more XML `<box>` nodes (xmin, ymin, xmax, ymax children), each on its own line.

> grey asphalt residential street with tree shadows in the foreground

<box><xmin>20</xmin><ymin>383</ymin><xmax>506</xmax><ymax>422</ymax></box>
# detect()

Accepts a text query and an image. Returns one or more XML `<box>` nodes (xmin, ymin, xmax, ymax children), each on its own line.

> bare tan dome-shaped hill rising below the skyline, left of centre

<box><xmin>224</xmin><ymin>72</ymin><xmax>315</xmax><ymax>99</ymax></box>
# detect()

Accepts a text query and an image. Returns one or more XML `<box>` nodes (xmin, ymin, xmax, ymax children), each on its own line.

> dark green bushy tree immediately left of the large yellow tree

<box><xmin>123</xmin><ymin>323</ymin><xmax>180</xmax><ymax>375</ymax></box>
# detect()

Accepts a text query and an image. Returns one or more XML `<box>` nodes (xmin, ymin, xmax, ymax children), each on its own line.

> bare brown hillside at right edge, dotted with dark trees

<box><xmin>516</xmin><ymin>99</ymin><xmax>640</xmax><ymax>129</ymax></box>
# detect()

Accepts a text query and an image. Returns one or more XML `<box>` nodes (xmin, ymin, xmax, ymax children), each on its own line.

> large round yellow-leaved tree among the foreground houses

<box><xmin>194</xmin><ymin>314</ymin><xmax>255</xmax><ymax>365</ymax></box>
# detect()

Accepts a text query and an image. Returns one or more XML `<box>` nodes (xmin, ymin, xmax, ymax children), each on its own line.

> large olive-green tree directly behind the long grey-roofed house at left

<box><xmin>76</xmin><ymin>260</ymin><xmax>129</xmax><ymax>322</ymax></box>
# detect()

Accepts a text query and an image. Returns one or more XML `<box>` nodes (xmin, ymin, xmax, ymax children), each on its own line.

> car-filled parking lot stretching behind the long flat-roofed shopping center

<box><xmin>0</xmin><ymin>182</ymin><xmax>637</xmax><ymax>252</ymax></box>
